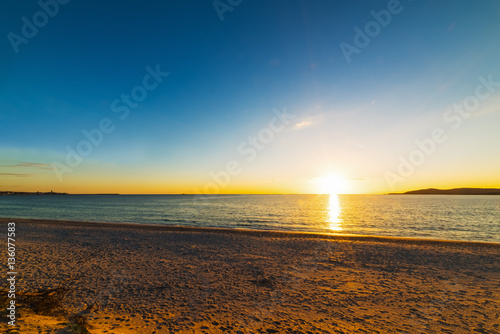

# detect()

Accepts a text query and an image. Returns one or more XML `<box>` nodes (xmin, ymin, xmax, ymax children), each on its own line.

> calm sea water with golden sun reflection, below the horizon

<box><xmin>0</xmin><ymin>195</ymin><xmax>500</xmax><ymax>242</ymax></box>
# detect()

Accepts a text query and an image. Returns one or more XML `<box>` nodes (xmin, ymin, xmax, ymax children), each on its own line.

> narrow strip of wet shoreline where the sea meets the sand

<box><xmin>0</xmin><ymin>217</ymin><xmax>500</xmax><ymax>248</ymax></box>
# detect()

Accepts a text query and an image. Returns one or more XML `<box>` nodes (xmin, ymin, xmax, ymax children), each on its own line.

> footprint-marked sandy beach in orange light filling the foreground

<box><xmin>1</xmin><ymin>219</ymin><xmax>500</xmax><ymax>333</ymax></box>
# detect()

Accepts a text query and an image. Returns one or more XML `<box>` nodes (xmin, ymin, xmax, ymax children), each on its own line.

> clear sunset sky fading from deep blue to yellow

<box><xmin>0</xmin><ymin>0</ymin><xmax>500</xmax><ymax>194</ymax></box>
